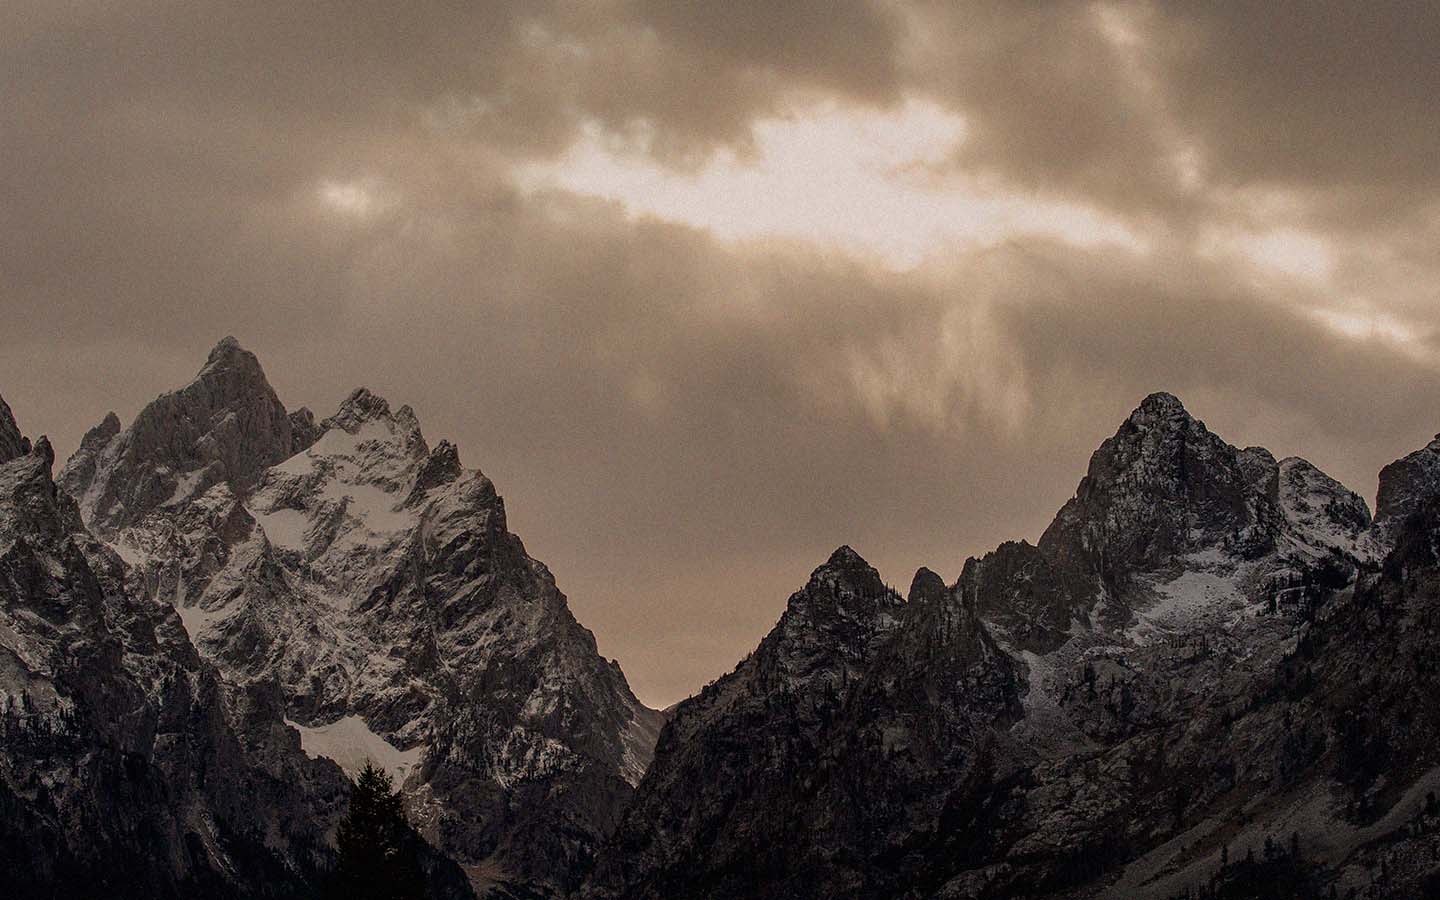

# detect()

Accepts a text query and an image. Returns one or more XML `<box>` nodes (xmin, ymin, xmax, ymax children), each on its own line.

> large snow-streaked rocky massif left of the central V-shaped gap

<box><xmin>62</xmin><ymin>338</ymin><xmax>661</xmax><ymax>893</ymax></box>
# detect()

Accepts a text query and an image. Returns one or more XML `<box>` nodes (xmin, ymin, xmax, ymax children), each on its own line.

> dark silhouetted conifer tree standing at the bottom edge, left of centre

<box><xmin>330</xmin><ymin>760</ymin><xmax>425</xmax><ymax>900</ymax></box>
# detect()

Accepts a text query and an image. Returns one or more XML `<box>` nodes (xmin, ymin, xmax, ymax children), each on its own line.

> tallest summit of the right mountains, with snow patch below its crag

<box><xmin>959</xmin><ymin>393</ymin><xmax>1369</xmax><ymax>654</ymax></box>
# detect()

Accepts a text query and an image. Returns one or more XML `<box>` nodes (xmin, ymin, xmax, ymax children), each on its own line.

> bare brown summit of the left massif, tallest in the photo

<box><xmin>60</xmin><ymin>337</ymin><xmax>294</xmax><ymax>536</ymax></box>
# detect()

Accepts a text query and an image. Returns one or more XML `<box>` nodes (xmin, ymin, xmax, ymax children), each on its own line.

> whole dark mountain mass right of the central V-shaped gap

<box><xmin>582</xmin><ymin>395</ymin><xmax>1440</xmax><ymax>899</ymax></box>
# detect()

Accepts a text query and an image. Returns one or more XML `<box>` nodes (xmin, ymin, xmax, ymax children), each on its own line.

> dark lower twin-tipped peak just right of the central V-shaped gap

<box><xmin>580</xmin><ymin>547</ymin><xmax>1020</xmax><ymax>900</ymax></box>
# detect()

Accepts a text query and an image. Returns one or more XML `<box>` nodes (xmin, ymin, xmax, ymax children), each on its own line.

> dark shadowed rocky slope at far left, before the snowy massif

<box><xmin>0</xmin><ymin>403</ymin><xmax>346</xmax><ymax>899</ymax></box>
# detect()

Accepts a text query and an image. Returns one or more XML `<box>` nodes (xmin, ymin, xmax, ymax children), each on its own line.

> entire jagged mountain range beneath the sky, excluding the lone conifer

<box><xmin>0</xmin><ymin>338</ymin><xmax>1440</xmax><ymax>900</ymax></box>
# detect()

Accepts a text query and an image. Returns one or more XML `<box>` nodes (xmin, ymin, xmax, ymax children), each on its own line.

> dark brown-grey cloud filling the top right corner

<box><xmin>1155</xmin><ymin>0</ymin><xmax>1440</xmax><ymax>216</ymax></box>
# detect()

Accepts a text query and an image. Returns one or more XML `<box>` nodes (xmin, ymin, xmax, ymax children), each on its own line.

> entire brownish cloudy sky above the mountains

<box><xmin>0</xmin><ymin>0</ymin><xmax>1440</xmax><ymax>704</ymax></box>
